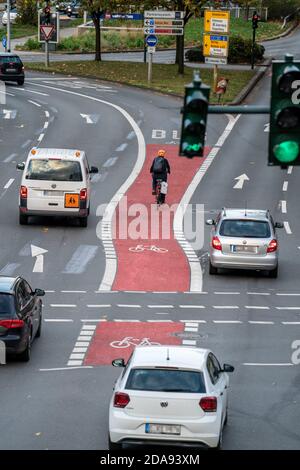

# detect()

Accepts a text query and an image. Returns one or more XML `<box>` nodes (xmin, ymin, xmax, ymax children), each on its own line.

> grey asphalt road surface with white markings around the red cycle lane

<box><xmin>0</xmin><ymin>26</ymin><xmax>300</xmax><ymax>450</ymax></box>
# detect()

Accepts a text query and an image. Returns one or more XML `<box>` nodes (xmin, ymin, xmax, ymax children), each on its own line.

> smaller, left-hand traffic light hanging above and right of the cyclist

<box><xmin>179</xmin><ymin>73</ymin><xmax>210</xmax><ymax>158</ymax></box>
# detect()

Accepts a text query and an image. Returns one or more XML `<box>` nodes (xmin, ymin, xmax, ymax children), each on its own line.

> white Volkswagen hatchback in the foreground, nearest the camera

<box><xmin>108</xmin><ymin>346</ymin><xmax>234</xmax><ymax>450</ymax></box>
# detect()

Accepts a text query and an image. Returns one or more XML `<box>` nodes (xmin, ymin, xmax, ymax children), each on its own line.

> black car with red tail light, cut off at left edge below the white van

<box><xmin>0</xmin><ymin>276</ymin><xmax>45</xmax><ymax>361</ymax></box>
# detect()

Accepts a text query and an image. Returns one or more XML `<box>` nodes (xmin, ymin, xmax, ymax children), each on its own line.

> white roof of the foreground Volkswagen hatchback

<box><xmin>131</xmin><ymin>345</ymin><xmax>210</xmax><ymax>370</ymax></box>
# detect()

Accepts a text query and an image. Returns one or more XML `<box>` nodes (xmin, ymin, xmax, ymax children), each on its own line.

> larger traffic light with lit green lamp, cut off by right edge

<box><xmin>268</xmin><ymin>54</ymin><xmax>300</xmax><ymax>168</ymax></box>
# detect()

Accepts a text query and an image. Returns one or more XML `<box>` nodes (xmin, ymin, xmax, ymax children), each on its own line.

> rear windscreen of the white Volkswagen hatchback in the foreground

<box><xmin>126</xmin><ymin>368</ymin><xmax>205</xmax><ymax>393</ymax></box>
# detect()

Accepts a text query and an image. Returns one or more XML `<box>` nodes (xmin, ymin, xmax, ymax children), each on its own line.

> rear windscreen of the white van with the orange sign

<box><xmin>26</xmin><ymin>158</ymin><xmax>82</xmax><ymax>181</ymax></box>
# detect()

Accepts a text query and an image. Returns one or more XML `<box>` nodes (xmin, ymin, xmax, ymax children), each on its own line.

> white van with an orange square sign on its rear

<box><xmin>17</xmin><ymin>148</ymin><xmax>98</xmax><ymax>227</ymax></box>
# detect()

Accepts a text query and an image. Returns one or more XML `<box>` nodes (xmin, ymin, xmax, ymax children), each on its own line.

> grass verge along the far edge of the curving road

<box><xmin>26</xmin><ymin>61</ymin><xmax>254</xmax><ymax>103</ymax></box>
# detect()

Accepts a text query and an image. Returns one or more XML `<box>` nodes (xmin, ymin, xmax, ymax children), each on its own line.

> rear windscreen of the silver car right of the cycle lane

<box><xmin>219</xmin><ymin>219</ymin><xmax>271</xmax><ymax>238</ymax></box>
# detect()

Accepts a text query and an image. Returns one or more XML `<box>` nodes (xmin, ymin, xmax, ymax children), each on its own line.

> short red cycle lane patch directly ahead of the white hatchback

<box><xmin>84</xmin><ymin>322</ymin><xmax>184</xmax><ymax>366</ymax></box>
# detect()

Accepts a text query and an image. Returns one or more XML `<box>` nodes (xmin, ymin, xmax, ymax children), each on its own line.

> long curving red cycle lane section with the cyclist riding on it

<box><xmin>112</xmin><ymin>144</ymin><xmax>209</xmax><ymax>292</ymax></box>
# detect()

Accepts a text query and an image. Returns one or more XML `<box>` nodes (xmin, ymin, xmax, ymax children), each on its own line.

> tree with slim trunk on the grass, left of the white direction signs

<box><xmin>82</xmin><ymin>0</ymin><xmax>119</xmax><ymax>61</ymax></box>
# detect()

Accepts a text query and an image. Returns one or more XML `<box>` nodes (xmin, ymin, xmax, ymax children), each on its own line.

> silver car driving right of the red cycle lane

<box><xmin>206</xmin><ymin>208</ymin><xmax>283</xmax><ymax>278</ymax></box>
